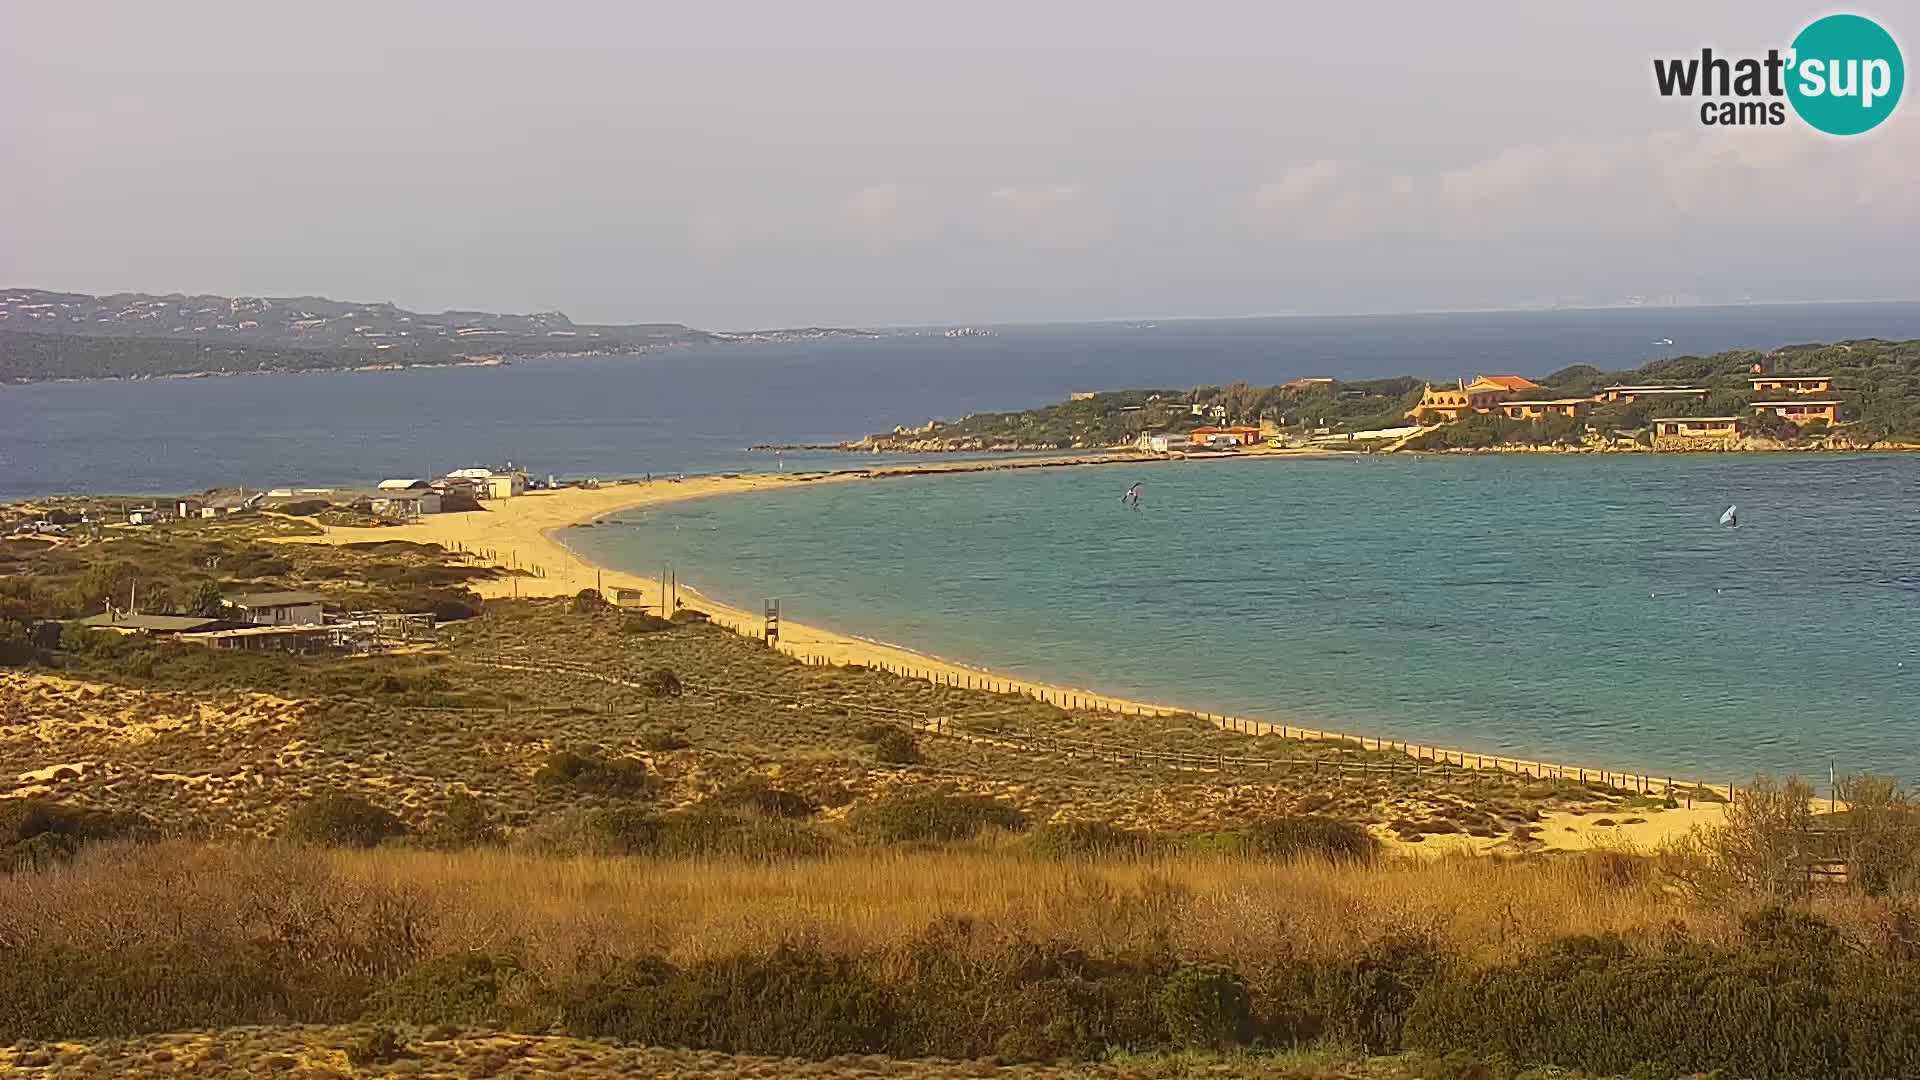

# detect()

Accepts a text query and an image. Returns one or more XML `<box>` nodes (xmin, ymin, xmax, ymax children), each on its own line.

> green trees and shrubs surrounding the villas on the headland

<box><xmin>849</xmin><ymin>340</ymin><xmax>1920</xmax><ymax>452</ymax></box>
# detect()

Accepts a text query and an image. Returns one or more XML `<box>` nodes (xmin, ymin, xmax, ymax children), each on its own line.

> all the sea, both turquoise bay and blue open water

<box><xmin>0</xmin><ymin>304</ymin><xmax>1920</xmax><ymax>782</ymax></box>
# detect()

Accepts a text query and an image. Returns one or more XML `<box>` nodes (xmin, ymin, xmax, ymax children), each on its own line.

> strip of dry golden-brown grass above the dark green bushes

<box><xmin>11</xmin><ymin>842</ymin><xmax>1904</xmax><ymax>976</ymax></box>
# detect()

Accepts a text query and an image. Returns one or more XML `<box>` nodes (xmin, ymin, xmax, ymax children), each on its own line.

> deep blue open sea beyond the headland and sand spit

<box><xmin>0</xmin><ymin>304</ymin><xmax>1920</xmax><ymax>500</ymax></box>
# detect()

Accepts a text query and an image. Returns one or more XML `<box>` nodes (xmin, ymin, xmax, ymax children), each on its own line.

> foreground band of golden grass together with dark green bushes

<box><xmin>0</xmin><ymin>842</ymin><xmax>1920</xmax><ymax>1078</ymax></box>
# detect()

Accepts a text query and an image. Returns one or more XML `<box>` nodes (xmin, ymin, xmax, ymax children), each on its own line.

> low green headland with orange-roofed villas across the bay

<box><xmin>837</xmin><ymin>338</ymin><xmax>1920</xmax><ymax>454</ymax></box>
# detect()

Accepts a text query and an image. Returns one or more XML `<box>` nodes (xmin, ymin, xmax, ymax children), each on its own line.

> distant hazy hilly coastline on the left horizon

<box><xmin>0</xmin><ymin>288</ymin><xmax>879</xmax><ymax>382</ymax></box>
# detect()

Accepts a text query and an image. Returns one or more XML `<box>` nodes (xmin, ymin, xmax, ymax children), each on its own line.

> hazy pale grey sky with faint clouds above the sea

<box><xmin>0</xmin><ymin>0</ymin><xmax>1920</xmax><ymax>329</ymax></box>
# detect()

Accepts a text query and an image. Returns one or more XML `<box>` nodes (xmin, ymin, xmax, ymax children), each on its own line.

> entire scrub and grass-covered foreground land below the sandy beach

<box><xmin>0</xmin><ymin>517</ymin><xmax>1920</xmax><ymax>1078</ymax></box>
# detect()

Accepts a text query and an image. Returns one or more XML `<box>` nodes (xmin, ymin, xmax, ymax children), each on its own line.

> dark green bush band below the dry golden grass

<box><xmin>0</xmin><ymin>899</ymin><xmax>1920</xmax><ymax>1080</ymax></box>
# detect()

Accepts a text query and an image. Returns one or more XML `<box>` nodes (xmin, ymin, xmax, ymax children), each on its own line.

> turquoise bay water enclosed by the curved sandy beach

<box><xmin>566</xmin><ymin>455</ymin><xmax>1920</xmax><ymax>782</ymax></box>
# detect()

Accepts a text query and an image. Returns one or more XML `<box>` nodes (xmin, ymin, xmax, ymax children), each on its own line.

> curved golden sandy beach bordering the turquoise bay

<box><xmin>280</xmin><ymin>454</ymin><xmax>1724</xmax><ymax>853</ymax></box>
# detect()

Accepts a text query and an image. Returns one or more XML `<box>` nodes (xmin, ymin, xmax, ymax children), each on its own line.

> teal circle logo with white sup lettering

<box><xmin>1788</xmin><ymin>15</ymin><xmax>1907</xmax><ymax>135</ymax></box>
